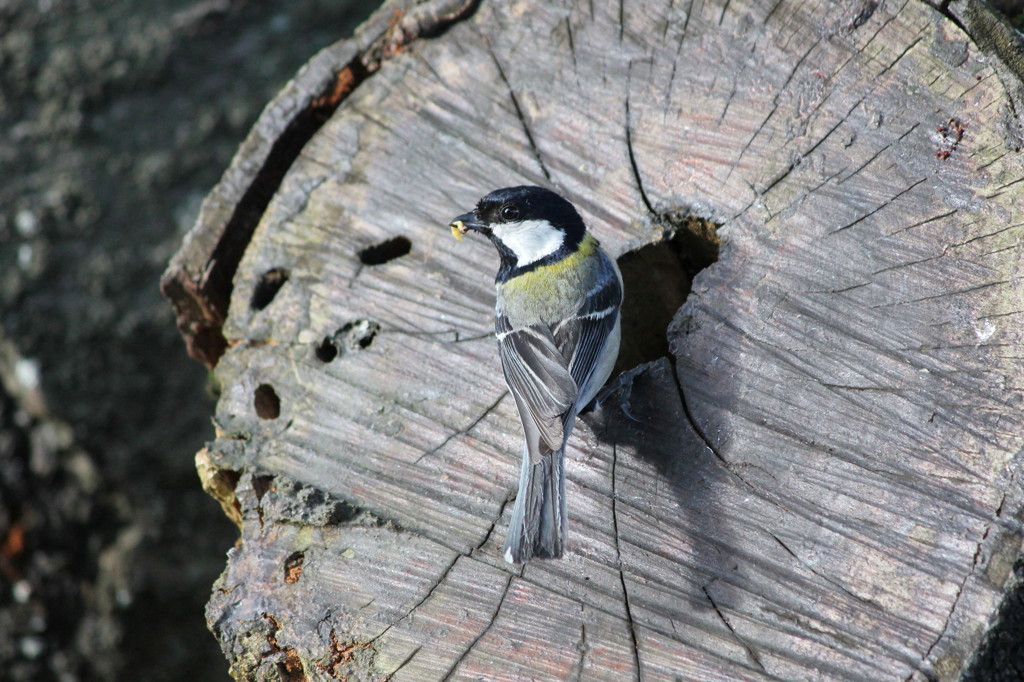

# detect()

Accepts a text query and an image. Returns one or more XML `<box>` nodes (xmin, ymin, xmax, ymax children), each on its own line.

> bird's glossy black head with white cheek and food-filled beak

<box><xmin>451</xmin><ymin>185</ymin><xmax>587</xmax><ymax>281</ymax></box>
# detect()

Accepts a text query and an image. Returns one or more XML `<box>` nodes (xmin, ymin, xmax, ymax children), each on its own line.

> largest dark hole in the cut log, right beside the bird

<box><xmin>615</xmin><ymin>213</ymin><xmax>721</xmax><ymax>374</ymax></box>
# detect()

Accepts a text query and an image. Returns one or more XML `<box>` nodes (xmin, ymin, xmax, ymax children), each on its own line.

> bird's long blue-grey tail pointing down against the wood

<box><xmin>505</xmin><ymin>447</ymin><xmax>568</xmax><ymax>563</ymax></box>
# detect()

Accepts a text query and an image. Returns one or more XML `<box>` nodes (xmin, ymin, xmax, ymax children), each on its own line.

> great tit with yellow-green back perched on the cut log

<box><xmin>450</xmin><ymin>186</ymin><xmax>623</xmax><ymax>563</ymax></box>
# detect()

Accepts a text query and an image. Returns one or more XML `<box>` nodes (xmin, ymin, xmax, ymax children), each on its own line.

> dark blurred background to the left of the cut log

<box><xmin>0</xmin><ymin>0</ymin><xmax>380</xmax><ymax>682</ymax></box>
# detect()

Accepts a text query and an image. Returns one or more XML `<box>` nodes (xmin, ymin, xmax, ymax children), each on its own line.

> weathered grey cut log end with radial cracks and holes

<box><xmin>164</xmin><ymin>0</ymin><xmax>1024</xmax><ymax>680</ymax></box>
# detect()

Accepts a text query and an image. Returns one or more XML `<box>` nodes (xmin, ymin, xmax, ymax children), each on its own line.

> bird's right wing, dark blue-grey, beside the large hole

<box><xmin>552</xmin><ymin>256</ymin><xmax>623</xmax><ymax>409</ymax></box>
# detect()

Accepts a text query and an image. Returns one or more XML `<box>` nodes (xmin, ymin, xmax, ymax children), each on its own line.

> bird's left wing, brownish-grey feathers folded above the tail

<box><xmin>496</xmin><ymin>313</ymin><xmax>578</xmax><ymax>459</ymax></box>
